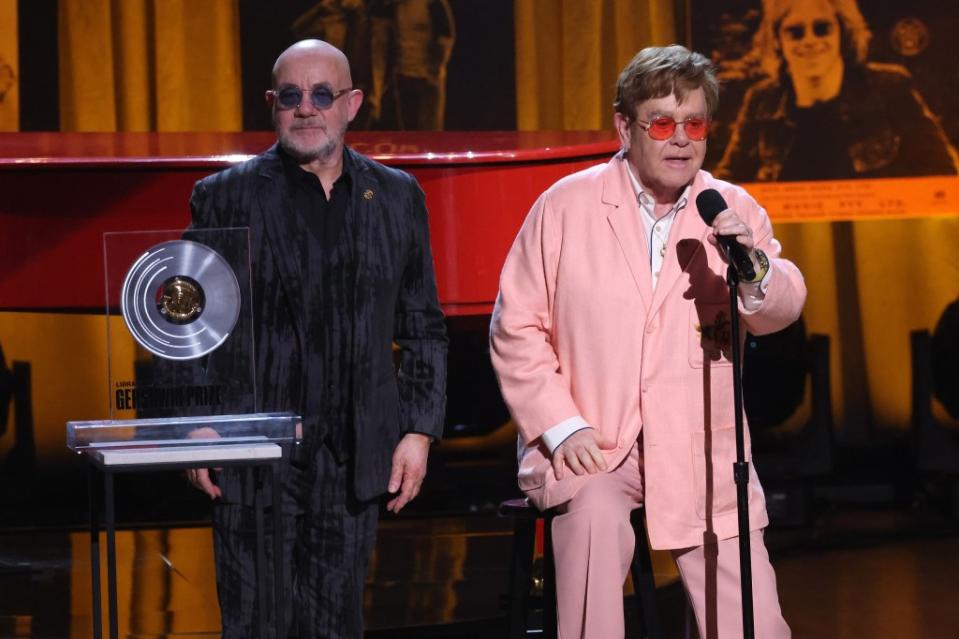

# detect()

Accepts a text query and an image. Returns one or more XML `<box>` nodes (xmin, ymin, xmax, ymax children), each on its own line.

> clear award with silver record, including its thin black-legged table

<box><xmin>67</xmin><ymin>228</ymin><xmax>300</xmax><ymax>639</ymax></box>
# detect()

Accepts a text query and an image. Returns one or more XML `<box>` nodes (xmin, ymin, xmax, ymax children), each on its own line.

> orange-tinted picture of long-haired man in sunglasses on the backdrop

<box><xmin>714</xmin><ymin>0</ymin><xmax>959</xmax><ymax>182</ymax></box>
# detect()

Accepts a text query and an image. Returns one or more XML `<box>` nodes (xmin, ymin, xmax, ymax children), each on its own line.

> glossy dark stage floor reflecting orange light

<box><xmin>0</xmin><ymin>508</ymin><xmax>959</xmax><ymax>639</ymax></box>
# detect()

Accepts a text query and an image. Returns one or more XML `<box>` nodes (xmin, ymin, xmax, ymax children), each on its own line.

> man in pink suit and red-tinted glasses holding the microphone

<box><xmin>491</xmin><ymin>45</ymin><xmax>806</xmax><ymax>639</ymax></box>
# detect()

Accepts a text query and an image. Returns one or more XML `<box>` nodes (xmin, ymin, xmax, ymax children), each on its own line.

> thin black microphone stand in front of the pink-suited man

<box><xmin>726</xmin><ymin>263</ymin><xmax>755</xmax><ymax>639</ymax></box>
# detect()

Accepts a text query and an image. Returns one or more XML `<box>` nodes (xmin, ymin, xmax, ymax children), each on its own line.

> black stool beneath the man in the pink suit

<box><xmin>499</xmin><ymin>498</ymin><xmax>662</xmax><ymax>639</ymax></box>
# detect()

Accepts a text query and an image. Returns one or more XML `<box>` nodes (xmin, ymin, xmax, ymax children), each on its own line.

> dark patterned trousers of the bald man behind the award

<box><xmin>213</xmin><ymin>446</ymin><xmax>379</xmax><ymax>639</ymax></box>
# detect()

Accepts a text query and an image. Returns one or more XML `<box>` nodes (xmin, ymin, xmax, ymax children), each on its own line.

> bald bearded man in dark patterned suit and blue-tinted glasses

<box><xmin>190</xmin><ymin>40</ymin><xmax>447</xmax><ymax>637</ymax></box>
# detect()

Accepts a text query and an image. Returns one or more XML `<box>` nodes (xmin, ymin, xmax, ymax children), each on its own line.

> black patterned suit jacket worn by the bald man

<box><xmin>190</xmin><ymin>146</ymin><xmax>447</xmax><ymax>501</ymax></box>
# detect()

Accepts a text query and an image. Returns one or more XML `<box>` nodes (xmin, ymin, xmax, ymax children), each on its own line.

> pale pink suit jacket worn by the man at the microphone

<box><xmin>490</xmin><ymin>154</ymin><xmax>806</xmax><ymax>548</ymax></box>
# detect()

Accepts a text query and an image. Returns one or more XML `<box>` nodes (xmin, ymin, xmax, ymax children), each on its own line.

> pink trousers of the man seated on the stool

<box><xmin>553</xmin><ymin>444</ymin><xmax>790</xmax><ymax>639</ymax></box>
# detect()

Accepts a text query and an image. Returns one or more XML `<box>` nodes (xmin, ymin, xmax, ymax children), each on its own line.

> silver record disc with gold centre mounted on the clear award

<box><xmin>120</xmin><ymin>240</ymin><xmax>241</xmax><ymax>360</ymax></box>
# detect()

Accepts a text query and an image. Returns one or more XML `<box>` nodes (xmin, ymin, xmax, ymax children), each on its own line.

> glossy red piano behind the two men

<box><xmin>0</xmin><ymin>131</ymin><xmax>618</xmax><ymax>315</ymax></box>
